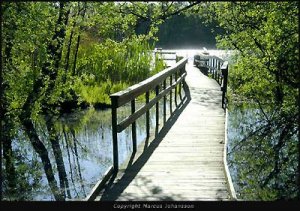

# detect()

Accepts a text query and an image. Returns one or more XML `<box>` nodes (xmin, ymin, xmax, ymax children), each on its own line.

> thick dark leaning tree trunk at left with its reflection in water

<box><xmin>19</xmin><ymin>2</ymin><xmax>70</xmax><ymax>200</ymax></box>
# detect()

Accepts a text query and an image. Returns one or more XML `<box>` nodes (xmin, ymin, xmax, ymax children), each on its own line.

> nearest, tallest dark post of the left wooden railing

<box><xmin>111</xmin><ymin>97</ymin><xmax>119</xmax><ymax>173</ymax></box>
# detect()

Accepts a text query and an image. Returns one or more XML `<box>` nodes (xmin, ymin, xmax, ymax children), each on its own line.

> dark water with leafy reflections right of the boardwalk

<box><xmin>227</xmin><ymin>105</ymin><xmax>299</xmax><ymax>201</ymax></box>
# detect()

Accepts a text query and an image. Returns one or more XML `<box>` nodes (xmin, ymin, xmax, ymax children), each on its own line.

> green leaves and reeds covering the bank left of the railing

<box><xmin>2</xmin><ymin>2</ymin><xmax>166</xmax><ymax>113</ymax></box>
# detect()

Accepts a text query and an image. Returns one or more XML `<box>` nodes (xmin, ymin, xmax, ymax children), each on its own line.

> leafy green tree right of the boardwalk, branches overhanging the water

<box><xmin>200</xmin><ymin>2</ymin><xmax>300</xmax><ymax>200</ymax></box>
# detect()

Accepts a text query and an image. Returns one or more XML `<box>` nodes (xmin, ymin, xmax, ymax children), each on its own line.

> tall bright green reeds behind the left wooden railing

<box><xmin>75</xmin><ymin>36</ymin><xmax>163</xmax><ymax>104</ymax></box>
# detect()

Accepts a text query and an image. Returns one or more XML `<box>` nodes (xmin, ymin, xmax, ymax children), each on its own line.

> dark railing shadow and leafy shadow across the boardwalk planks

<box><xmin>96</xmin><ymin>85</ymin><xmax>191</xmax><ymax>201</ymax></box>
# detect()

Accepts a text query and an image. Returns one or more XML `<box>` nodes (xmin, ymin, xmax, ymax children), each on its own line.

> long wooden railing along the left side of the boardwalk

<box><xmin>110</xmin><ymin>58</ymin><xmax>188</xmax><ymax>172</ymax></box>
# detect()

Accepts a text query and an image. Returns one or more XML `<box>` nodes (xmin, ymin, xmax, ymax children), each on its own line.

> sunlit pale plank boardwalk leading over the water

<box><xmin>95</xmin><ymin>60</ymin><xmax>231</xmax><ymax>201</ymax></box>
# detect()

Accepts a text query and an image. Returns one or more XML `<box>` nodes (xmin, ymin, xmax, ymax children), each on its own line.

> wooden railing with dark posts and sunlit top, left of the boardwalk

<box><xmin>110</xmin><ymin>58</ymin><xmax>187</xmax><ymax>173</ymax></box>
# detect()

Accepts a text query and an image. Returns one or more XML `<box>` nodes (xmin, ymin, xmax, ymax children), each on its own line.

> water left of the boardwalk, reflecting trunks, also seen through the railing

<box><xmin>3</xmin><ymin>94</ymin><xmax>175</xmax><ymax>201</ymax></box>
